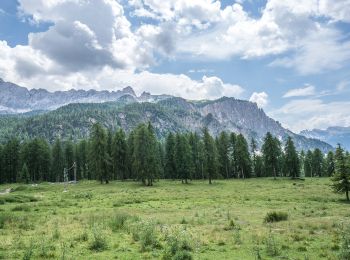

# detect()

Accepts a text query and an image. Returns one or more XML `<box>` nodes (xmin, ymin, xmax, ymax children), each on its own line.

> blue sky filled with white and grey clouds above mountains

<box><xmin>0</xmin><ymin>0</ymin><xmax>350</xmax><ymax>132</ymax></box>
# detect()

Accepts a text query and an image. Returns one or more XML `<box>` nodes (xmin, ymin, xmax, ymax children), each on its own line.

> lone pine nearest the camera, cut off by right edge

<box><xmin>332</xmin><ymin>144</ymin><xmax>350</xmax><ymax>201</ymax></box>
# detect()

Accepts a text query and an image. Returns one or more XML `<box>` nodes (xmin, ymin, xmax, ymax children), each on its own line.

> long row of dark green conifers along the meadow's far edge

<box><xmin>0</xmin><ymin>124</ymin><xmax>350</xmax><ymax>186</ymax></box>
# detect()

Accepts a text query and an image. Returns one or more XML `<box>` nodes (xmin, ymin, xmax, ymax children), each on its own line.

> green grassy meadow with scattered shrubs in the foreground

<box><xmin>0</xmin><ymin>178</ymin><xmax>350</xmax><ymax>260</ymax></box>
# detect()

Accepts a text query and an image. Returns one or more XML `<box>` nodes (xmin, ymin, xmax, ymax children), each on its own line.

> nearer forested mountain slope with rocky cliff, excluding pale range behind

<box><xmin>0</xmin><ymin>91</ymin><xmax>332</xmax><ymax>152</ymax></box>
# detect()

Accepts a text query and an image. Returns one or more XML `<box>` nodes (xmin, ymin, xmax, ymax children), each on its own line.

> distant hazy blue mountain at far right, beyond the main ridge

<box><xmin>300</xmin><ymin>126</ymin><xmax>350</xmax><ymax>151</ymax></box>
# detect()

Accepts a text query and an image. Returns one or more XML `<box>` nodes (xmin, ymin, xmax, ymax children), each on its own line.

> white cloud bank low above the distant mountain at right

<box><xmin>268</xmin><ymin>98</ymin><xmax>350</xmax><ymax>132</ymax></box>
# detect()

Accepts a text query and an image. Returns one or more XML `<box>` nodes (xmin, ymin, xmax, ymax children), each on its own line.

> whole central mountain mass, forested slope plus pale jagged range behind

<box><xmin>0</xmin><ymin>79</ymin><xmax>332</xmax><ymax>152</ymax></box>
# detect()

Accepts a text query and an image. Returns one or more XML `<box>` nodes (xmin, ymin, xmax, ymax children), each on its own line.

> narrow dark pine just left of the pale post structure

<box><xmin>51</xmin><ymin>138</ymin><xmax>64</xmax><ymax>182</ymax></box>
